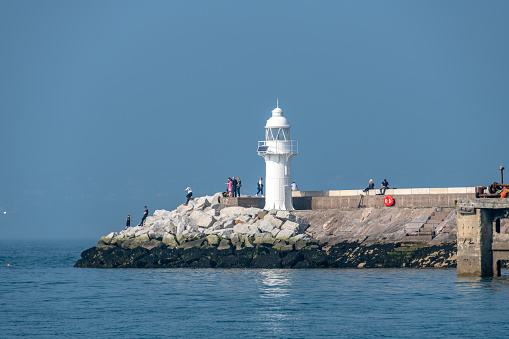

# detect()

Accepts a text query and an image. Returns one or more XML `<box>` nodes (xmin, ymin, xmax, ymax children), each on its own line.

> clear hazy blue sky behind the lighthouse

<box><xmin>0</xmin><ymin>0</ymin><xmax>509</xmax><ymax>239</ymax></box>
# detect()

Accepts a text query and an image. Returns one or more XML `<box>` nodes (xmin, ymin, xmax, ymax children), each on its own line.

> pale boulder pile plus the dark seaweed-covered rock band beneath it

<box><xmin>75</xmin><ymin>193</ymin><xmax>456</xmax><ymax>268</ymax></box>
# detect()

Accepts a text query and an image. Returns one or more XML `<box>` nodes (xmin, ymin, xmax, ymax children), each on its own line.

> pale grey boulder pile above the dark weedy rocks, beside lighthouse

<box><xmin>97</xmin><ymin>193</ymin><xmax>310</xmax><ymax>249</ymax></box>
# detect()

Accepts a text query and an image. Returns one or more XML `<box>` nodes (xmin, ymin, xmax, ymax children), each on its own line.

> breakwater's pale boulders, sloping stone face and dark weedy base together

<box><xmin>75</xmin><ymin>193</ymin><xmax>456</xmax><ymax>268</ymax></box>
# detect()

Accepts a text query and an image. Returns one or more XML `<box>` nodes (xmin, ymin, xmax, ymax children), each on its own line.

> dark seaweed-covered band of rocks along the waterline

<box><xmin>75</xmin><ymin>239</ymin><xmax>456</xmax><ymax>269</ymax></box>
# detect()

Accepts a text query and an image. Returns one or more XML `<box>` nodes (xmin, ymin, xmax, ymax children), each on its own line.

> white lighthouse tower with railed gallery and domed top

<box><xmin>258</xmin><ymin>102</ymin><xmax>299</xmax><ymax>210</ymax></box>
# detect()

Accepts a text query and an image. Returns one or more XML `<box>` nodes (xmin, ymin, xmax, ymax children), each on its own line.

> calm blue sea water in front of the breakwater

<box><xmin>0</xmin><ymin>241</ymin><xmax>509</xmax><ymax>338</ymax></box>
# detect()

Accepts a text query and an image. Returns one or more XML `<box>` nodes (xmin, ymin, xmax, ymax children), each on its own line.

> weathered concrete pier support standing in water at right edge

<box><xmin>456</xmin><ymin>199</ymin><xmax>509</xmax><ymax>276</ymax></box>
